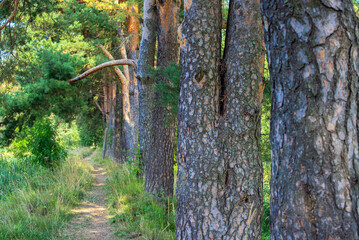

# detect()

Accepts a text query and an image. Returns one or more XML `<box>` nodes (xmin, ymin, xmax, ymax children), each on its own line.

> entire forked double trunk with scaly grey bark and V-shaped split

<box><xmin>177</xmin><ymin>0</ymin><xmax>264</xmax><ymax>239</ymax></box>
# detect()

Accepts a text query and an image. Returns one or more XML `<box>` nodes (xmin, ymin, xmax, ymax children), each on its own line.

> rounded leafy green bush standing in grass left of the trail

<box><xmin>12</xmin><ymin>118</ymin><xmax>66</xmax><ymax>168</ymax></box>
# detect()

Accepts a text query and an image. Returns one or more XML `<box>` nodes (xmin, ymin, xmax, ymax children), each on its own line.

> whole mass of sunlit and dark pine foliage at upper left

<box><xmin>0</xmin><ymin>0</ymin><xmax>114</xmax><ymax>146</ymax></box>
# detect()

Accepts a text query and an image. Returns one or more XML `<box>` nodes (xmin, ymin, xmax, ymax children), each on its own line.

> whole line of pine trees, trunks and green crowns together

<box><xmin>0</xmin><ymin>0</ymin><xmax>359</xmax><ymax>239</ymax></box>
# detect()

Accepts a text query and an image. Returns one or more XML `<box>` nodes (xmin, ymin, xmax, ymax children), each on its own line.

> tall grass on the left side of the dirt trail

<box><xmin>0</xmin><ymin>148</ymin><xmax>92</xmax><ymax>239</ymax></box>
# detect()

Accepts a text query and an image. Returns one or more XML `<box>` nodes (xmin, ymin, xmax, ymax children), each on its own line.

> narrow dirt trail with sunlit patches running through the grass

<box><xmin>63</xmin><ymin>152</ymin><xmax>115</xmax><ymax>240</ymax></box>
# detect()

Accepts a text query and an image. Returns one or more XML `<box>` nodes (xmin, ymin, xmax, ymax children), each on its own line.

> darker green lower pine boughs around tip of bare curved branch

<box><xmin>0</xmin><ymin>49</ymin><xmax>85</xmax><ymax>145</ymax></box>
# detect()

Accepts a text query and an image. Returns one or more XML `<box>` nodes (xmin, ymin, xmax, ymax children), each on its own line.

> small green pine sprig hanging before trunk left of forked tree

<box><xmin>151</xmin><ymin>62</ymin><xmax>181</xmax><ymax>122</ymax></box>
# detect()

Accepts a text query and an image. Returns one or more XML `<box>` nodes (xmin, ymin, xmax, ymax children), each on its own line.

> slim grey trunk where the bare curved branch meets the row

<box><xmin>137</xmin><ymin>0</ymin><xmax>157</xmax><ymax>172</ymax></box>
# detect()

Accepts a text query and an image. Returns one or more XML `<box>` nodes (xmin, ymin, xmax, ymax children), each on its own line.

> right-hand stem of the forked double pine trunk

<box><xmin>218</xmin><ymin>0</ymin><xmax>265</xmax><ymax>237</ymax></box>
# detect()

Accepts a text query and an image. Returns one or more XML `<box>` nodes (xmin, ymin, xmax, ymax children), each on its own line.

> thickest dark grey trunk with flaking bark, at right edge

<box><xmin>262</xmin><ymin>0</ymin><xmax>359</xmax><ymax>239</ymax></box>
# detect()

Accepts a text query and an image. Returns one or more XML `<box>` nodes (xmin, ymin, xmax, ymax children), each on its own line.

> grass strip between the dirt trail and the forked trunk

<box><xmin>96</xmin><ymin>151</ymin><xmax>176</xmax><ymax>240</ymax></box>
